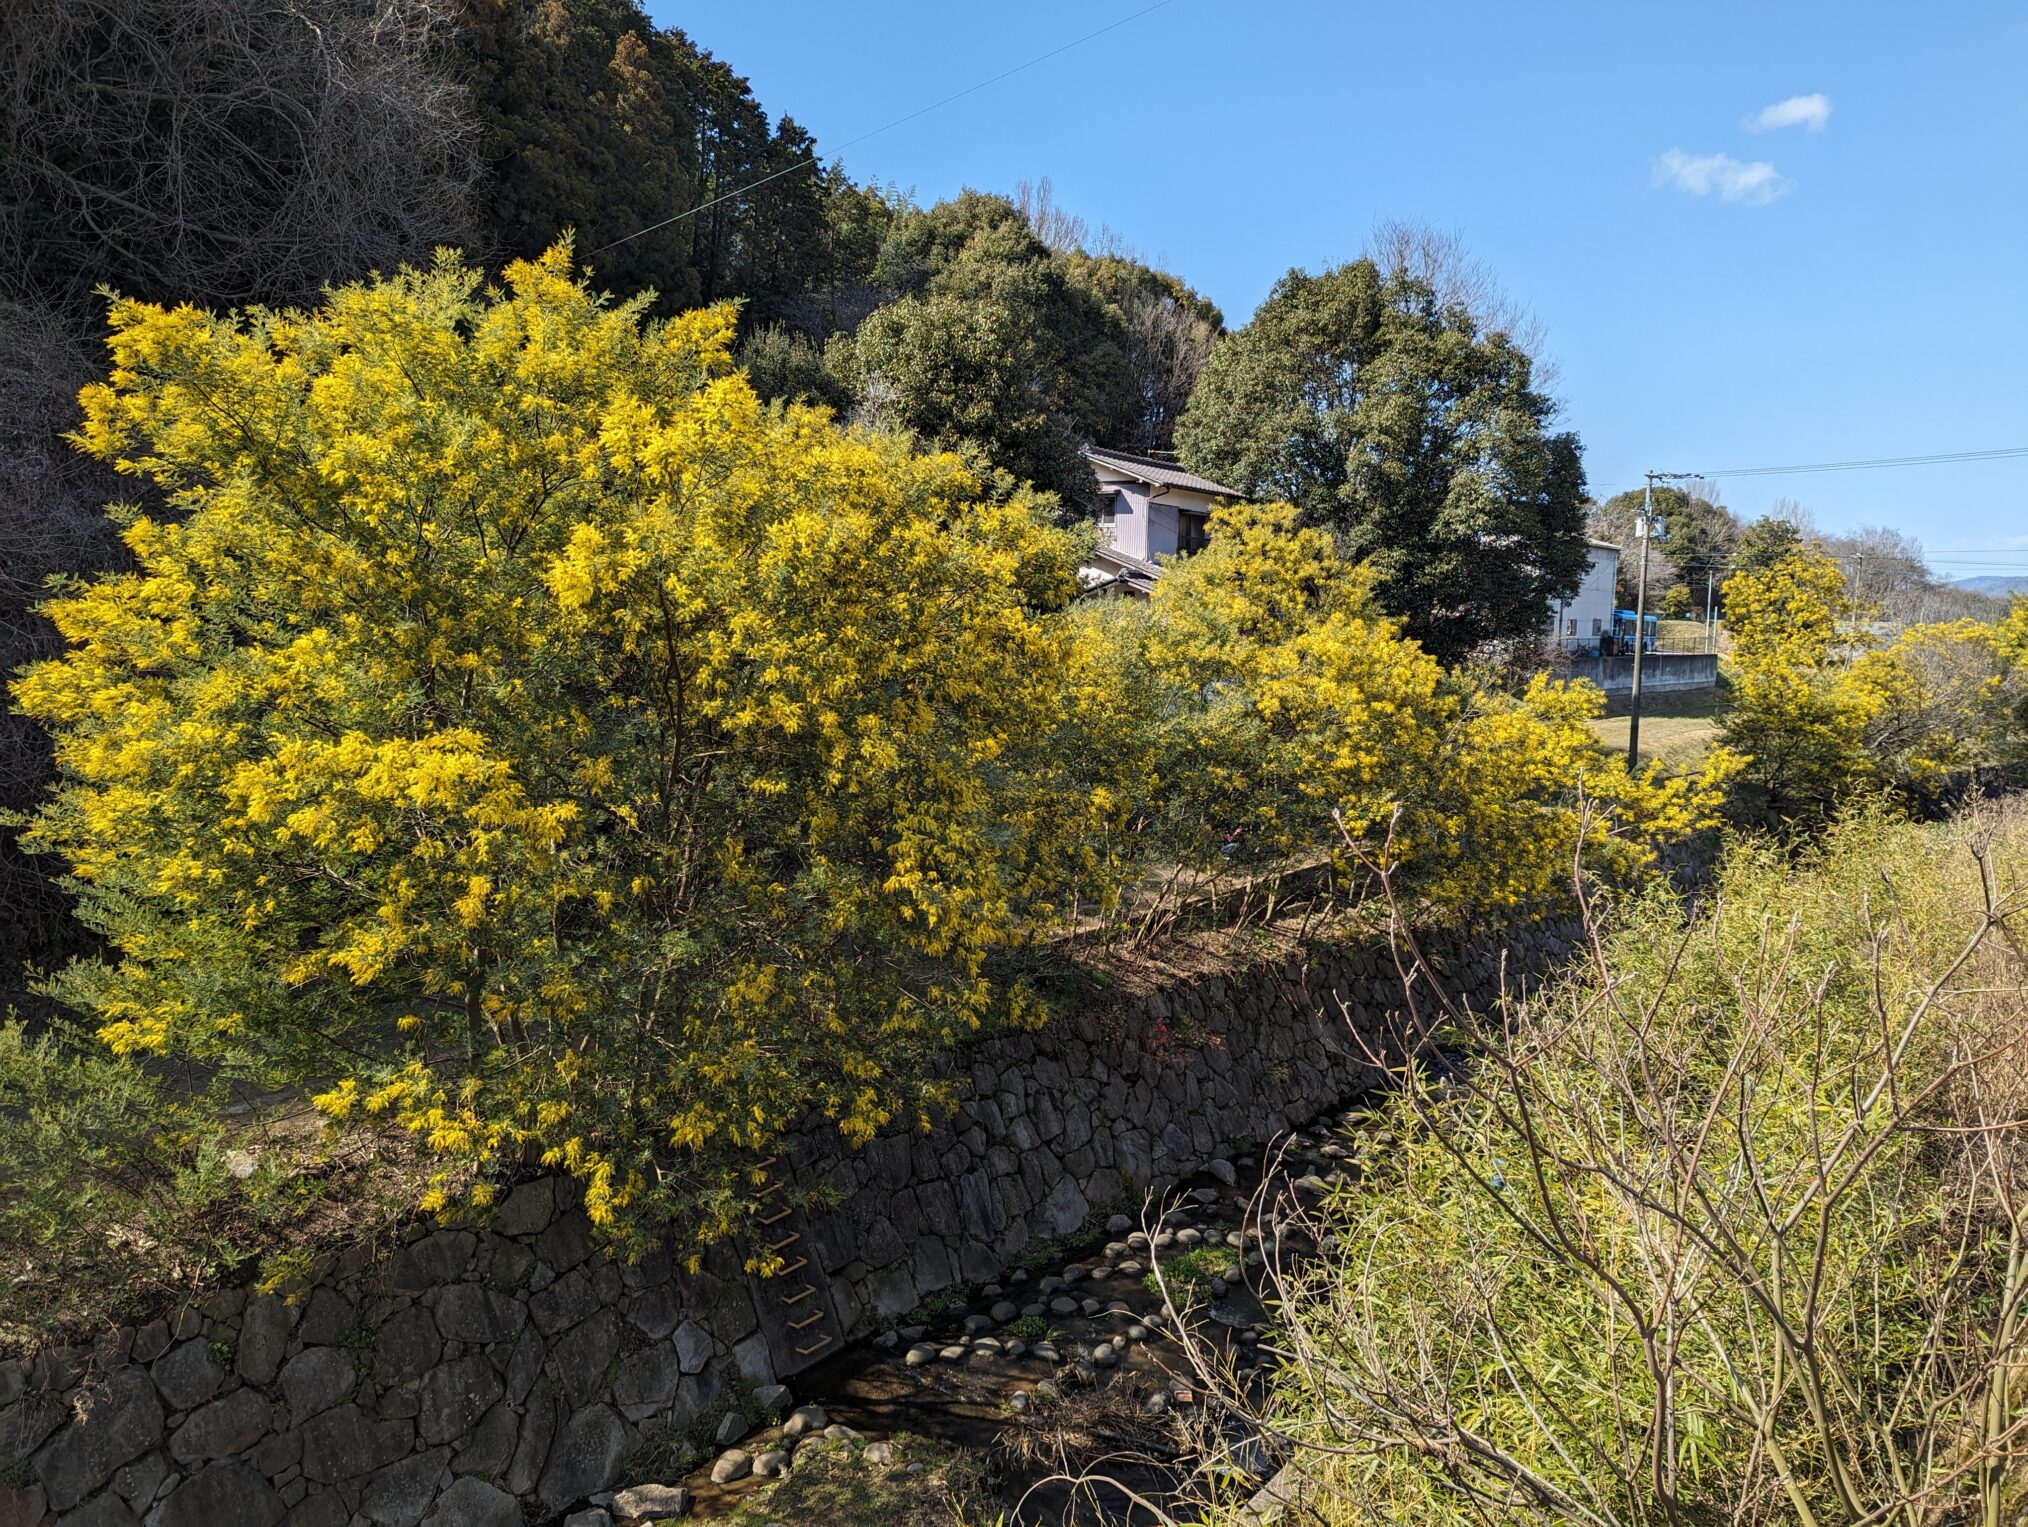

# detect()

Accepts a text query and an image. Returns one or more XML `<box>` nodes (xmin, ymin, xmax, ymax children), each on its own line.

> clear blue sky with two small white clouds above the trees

<box><xmin>649</xmin><ymin>0</ymin><xmax>2028</xmax><ymax>576</ymax></box>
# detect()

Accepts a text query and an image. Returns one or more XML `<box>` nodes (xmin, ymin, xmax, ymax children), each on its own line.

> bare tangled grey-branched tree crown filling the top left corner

<box><xmin>0</xmin><ymin>0</ymin><xmax>477</xmax><ymax>306</ymax></box>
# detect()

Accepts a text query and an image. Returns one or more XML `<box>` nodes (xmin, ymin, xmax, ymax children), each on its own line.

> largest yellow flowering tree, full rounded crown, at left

<box><xmin>16</xmin><ymin>247</ymin><xmax>1113</xmax><ymax>1235</ymax></box>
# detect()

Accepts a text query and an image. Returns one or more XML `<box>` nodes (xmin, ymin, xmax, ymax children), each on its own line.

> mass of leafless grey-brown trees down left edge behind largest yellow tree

<box><xmin>0</xmin><ymin>0</ymin><xmax>479</xmax><ymax>1000</ymax></box>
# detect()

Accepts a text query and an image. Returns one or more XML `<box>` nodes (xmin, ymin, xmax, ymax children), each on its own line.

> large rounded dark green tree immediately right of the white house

<box><xmin>1176</xmin><ymin>260</ymin><xmax>1586</xmax><ymax>659</ymax></box>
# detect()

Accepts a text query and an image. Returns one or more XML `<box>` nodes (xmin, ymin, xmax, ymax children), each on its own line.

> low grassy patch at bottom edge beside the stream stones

<box><xmin>730</xmin><ymin>1434</ymin><xmax>992</xmax><ymax>1527</ymax></box>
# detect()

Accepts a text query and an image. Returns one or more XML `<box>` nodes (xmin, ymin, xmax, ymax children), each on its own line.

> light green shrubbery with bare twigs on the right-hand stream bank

<box><xmin>1184</xmin><ymin>807</ymin><xmax>2028</xmax><ymax>1527</ymax></box>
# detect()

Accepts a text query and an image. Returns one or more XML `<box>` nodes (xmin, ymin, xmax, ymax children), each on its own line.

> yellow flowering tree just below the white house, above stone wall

<box><xmin>1105</xmin><ymin>505</ymin><xmax>1736</xmax><ymax>911</ymax></box>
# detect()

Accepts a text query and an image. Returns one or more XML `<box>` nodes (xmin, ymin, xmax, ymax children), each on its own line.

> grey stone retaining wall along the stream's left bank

<box><xmin>0</xmin><ymin>912</ymin><xmax>1570</xmax><ymax>1527</ymax></box>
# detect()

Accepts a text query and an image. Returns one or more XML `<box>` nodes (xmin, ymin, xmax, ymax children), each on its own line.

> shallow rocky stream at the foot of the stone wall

<box><xmin>657</xmin><ymin>1105</ymin><xmax>1389</xmax><ymax>1527</ymax></box>
